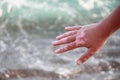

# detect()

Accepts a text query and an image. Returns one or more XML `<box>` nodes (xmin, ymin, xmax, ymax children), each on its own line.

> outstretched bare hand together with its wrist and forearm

<box><xmin>52</xmin><ymin>6</ymin><xmax>120</xmax><ymax>64</ymax></box>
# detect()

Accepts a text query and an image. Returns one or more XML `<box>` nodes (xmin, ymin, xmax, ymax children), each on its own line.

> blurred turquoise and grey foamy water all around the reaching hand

<box><xmin>0</xmin><ymin>0</ymin><xmax>120</xmax><ymax>80</ymax></box>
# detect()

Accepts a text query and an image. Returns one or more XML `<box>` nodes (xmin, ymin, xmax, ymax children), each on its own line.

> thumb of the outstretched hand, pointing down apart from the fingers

<box><xmin>77</xmin><ymin>48</ymin><xmax>96</xmax><ymax>65</ymax></box>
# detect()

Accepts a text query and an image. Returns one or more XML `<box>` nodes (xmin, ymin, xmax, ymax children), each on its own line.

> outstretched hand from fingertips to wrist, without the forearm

<box><xmin>53</xmin><ymin>23</ymin><xmax>108</xmax><ymax>64</ymax></box>
